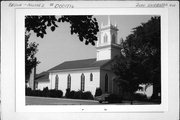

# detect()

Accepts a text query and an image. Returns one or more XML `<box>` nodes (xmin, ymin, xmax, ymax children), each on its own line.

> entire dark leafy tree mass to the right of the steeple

<box><xmin>112</xmin><ymin>16</ymin><xmax>161</xmax><ymax>102</ymax></box>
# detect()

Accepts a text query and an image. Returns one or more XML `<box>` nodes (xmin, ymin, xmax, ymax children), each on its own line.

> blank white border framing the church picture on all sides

<box><xmin>15</xmin><ymin>8</ymin><xmax>168</xmax><ymax>112</ymax></box>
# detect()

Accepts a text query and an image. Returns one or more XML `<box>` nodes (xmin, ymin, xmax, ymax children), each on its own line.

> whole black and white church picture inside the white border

<box><xmin>24</xmin><ymin>15</ymin><xmax>161</xmax><ymax>105</ymax></box>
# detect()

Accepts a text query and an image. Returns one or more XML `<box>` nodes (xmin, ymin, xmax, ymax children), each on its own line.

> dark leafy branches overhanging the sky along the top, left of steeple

<box><xmin>25</xmin><ymin>15</ymin><xmax>99</xmax><ymax>45</ymax></box>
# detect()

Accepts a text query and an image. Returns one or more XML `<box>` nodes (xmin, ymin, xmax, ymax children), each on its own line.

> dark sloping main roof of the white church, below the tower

<box><xmin>48</xmin><ymin>58</ymin><xmax>110</xmax><ymax>72</ymax></box>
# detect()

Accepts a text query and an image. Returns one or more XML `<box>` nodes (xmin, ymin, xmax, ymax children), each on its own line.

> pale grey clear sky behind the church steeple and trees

<box><xmin>29</xmin><ymin>15</ymin><xmax>152</xmax><ymax>74</ymax></box>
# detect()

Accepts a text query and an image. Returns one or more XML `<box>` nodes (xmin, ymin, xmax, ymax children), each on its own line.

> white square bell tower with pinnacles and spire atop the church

<box><xmin>96</xmin><ymin>16</ymin><xmax>120</xmax><ymax>61</ymax></box>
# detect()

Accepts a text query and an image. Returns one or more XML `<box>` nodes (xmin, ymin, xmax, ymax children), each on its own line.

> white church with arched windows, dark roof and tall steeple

<box><xmin>29</xmin><ymin>19</ymin><xmax>124</xmax><ymax>95</ymax></box>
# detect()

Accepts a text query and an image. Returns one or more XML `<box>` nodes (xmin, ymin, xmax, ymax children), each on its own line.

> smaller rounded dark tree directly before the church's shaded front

<box><xmin>112</xmin><ymin>50</ymin><xmax>139</xmax><ymax>103</ymax></box>
